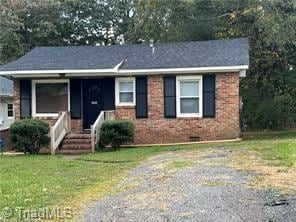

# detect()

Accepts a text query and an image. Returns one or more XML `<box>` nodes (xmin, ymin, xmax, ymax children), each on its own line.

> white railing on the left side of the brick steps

<box><xmin>50</xmin><ymin>112</ymin><xmax>71</xmax><ymax>155</ymax></box>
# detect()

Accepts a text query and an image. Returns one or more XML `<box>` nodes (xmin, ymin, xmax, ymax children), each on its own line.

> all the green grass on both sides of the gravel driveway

<box><xmin>0</xmin><ymin>131</ymin><xmax>296</xmax><ymax>219</ymax></box>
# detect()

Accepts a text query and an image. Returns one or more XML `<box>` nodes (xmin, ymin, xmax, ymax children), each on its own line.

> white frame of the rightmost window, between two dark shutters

<box><xmin>176</xmin><ymin>75</ymin><xmax>203</xmax><ymax>118</ymax></box>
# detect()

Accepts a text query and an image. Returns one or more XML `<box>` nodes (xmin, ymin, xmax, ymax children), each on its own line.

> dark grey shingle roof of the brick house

<box><xmin>0</xmin><ymin>38</ymin><xmax>249</xmax><ymax>71</ymax></box>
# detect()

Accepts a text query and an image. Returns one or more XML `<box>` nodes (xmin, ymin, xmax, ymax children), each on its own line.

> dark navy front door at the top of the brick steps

<box><xmin>83</xmin><ymin>79</ymin><xmax>103</xmax><ymax>129</ymax></box>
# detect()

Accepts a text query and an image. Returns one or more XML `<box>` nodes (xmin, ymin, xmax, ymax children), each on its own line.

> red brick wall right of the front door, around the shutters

<box><xmin>116</xmin><ymin>73</ymin><xmax>240</xmax><ymax>144</ymax></box>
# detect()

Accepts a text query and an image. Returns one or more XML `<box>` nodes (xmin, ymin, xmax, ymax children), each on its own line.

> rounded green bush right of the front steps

<box><xmin>100</xmin><ymin>120</ymin><xmax>134</xmax><ymax>149</ymax></box>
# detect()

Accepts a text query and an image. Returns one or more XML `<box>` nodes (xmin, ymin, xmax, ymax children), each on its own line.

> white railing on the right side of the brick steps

<box><xmin>91</xmin><ymin>110</ymin><xmax>115</xmax><ymax>153</ymax></box>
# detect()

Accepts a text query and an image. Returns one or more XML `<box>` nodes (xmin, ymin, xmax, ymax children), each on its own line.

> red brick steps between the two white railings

<box><xmin>57</xmin><ymin>134</ymin><xmax>91</xmax><ymax>155</ymax></box>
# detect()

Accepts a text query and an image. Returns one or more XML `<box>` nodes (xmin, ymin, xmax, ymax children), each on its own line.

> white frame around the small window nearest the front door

<box><xmin>115</xmin><ymin>77</ymin><xmax>136</xmax><ymax>106</ymax></box>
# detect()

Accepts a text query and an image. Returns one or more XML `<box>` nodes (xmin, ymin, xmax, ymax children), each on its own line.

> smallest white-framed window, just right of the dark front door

<box><xmin>115</xmin><ymin>78</ymin><xmax>135</xmax><ymax>106</ymax></box>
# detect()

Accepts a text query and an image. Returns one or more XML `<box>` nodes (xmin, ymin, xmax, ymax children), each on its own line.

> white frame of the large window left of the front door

<box><xmin>32</xmin><ymin>79</ymin><xmax>71</xmax><ymax>117</ymax></box>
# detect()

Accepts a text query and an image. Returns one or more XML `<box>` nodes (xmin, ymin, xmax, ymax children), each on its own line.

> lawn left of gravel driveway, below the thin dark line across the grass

<box><xmin>0</xmin><ymin>155</ymin><xmax>133</xmax><ymax>219</ymax></box>
